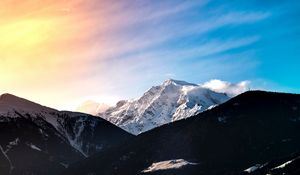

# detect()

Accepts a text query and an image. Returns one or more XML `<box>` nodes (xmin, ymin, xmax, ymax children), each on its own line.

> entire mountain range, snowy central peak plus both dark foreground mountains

<box><xmin>0</xmin><ymin>80</ymin><xmax>300</xmax><ymax>175</ymax></box>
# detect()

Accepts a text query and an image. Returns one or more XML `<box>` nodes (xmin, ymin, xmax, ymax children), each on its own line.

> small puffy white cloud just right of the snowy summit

<box><xmin>201</xmin><ymin>79</ymin><xmax>250</xmax><ymax>96</ymax></box>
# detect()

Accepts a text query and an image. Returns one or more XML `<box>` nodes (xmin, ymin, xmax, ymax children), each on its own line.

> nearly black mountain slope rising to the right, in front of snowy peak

<box><xmin>64</xmin><ymin>91</ymin><xmax>300</xmax><ymax>175</ymax></box>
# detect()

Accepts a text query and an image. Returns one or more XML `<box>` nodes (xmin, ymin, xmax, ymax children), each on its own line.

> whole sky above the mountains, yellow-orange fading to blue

<box><xmin>0</xmin><ymin>0</ymin><xmax>300</xmax><ymax>110</ymax></box>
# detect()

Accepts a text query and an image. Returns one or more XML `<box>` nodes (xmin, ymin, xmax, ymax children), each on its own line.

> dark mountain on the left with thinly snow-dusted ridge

<box><xmin>0</xmin><ymin>94</ymin><xmax>133</xmax><ymax>175</ymax></box>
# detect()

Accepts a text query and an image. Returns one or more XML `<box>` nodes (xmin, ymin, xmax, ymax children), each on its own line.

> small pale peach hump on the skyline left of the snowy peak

<box><xmin>76</xmin><ymin>100</ymin><xmax>109</xmax><ymax>115</ymax></box>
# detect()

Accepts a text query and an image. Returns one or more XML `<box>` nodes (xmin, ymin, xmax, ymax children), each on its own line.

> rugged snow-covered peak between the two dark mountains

<box><xmin>99</xmin><ymin>79</ymin><xmax>229</xmax><ymax>135</ymax></box>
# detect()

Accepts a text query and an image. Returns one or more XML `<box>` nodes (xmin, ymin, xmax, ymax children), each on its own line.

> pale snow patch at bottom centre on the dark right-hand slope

<box><xmin>142</xmin><ymin>159</ymin><xmax>197</xmax><ymax>173</ymax></box>
